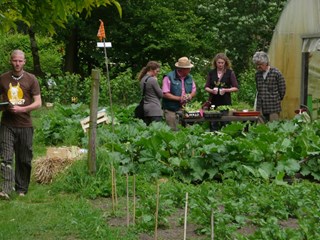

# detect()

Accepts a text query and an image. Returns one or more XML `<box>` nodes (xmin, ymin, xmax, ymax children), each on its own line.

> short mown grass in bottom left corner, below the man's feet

<box><xmin>0</xmin><ymin>184</ymin><xmax>136</xmax><ymax>240</ymax></box>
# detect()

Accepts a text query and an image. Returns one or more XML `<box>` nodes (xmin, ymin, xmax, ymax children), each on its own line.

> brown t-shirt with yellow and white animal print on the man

<box><xmin>0</xmin><ymin>71</ymin><xmax>40</xmax><ymax>127</ymax></box>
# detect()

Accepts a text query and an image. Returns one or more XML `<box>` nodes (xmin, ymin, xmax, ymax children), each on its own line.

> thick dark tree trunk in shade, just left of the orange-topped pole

<box><xmin>64</xmin><ymin>27</ymin><xmax>79</xmax><ymax>73</ymax></box>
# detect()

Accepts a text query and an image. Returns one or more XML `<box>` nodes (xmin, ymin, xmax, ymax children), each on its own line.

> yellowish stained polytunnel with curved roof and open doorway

<box><xmin>268</xmin><ymin>0</ymin><xmax>320</xmax><ymax>119</ymax></box>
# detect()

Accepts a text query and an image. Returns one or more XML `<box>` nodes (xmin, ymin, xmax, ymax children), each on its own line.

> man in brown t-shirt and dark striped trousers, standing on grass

<box><xmin>0</xmin><ymin>50</ymin><xmax>42</xmax><ymax>199</ymax></box>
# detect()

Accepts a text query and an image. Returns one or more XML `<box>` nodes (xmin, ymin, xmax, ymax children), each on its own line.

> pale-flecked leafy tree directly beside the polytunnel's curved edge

<box><xmin>198</xmin><ymin>0</ymin><xmax>287</xmax><ymax>73</ymax></box>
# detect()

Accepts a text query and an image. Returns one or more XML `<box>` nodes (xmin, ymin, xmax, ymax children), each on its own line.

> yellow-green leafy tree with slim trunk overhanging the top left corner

<box><xmin>0</xmin><ymin>0</ymin><xmax>122</xmax><ymax>75</ymax></box>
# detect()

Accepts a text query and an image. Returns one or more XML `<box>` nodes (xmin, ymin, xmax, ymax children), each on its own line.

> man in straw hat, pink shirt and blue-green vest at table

<box><xmin>162</xmin><ymin>57</ymin><xmax>196</xmax><ymax>131</ymax></box>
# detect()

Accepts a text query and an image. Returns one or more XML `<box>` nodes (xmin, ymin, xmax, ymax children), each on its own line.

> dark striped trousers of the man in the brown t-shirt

<box><xmin>0</xmin><ymin>126</ymin><xmax>33</xmax><ymax>194</ymax></box>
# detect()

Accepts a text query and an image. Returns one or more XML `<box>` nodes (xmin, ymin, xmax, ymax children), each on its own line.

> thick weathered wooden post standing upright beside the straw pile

<box><xmin>88</xmin><ymin>69</ymin><xmax>100</xmax><ymax>174</ymax></box>
